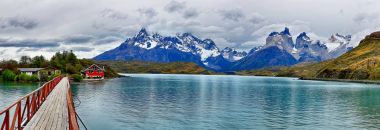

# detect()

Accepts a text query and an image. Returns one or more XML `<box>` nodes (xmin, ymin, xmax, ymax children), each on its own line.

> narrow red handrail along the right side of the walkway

<box><xmin>66</xmin><ymin>79</ymin><xmax>79</xmax><ymax>130</ymax></box>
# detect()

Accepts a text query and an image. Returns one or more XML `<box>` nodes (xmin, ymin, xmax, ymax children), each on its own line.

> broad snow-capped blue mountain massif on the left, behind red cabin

<box><xmin>94</xmin><ymin>28</ymin><xmax>230</xmax><ymax>70</ymax></box>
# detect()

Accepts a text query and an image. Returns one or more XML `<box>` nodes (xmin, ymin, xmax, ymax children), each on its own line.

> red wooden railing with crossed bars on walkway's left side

<box><xmin>0</xmin><ymin>76</ymin><xmax>62</xmax><ymax>130</ymax></box>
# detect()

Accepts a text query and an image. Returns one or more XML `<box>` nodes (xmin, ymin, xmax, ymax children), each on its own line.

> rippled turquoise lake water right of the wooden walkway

<box><xmin>72</xmin><ymin>74</ymin><xmax>380</xmax><ymax>130</ymax></box>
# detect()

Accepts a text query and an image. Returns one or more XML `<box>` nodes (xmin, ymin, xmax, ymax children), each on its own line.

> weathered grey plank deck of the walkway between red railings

<box><xmin>24</xmin><ymin>77</ymin><xmax>69</xmax><ymax>130</ymax></box>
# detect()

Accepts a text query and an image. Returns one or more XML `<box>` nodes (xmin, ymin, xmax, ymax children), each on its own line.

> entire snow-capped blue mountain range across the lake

<box><xmin>93</xmin><ymin>28</ymin><xmax>352</xmax><ymax>71</ymax></box>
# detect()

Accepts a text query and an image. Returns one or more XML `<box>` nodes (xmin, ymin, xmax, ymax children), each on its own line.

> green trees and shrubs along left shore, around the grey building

<box><xmin>0</xmin><ymin>51</ymin><xmax>119</xmax><ymax>82</ymax></box>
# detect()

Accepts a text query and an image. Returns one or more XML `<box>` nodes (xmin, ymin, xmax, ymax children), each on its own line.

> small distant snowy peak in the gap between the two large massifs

<box><xmin>221</xmin><ymin>47</ymin><xmax>247</xmax><ymax>62</ymax></box>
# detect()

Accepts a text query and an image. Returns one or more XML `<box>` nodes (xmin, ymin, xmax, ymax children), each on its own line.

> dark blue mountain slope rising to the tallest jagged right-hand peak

<box><xmin>232</xmin><ymin>28</ymin><xmax>298</xmax><ymax>70</ymax></box>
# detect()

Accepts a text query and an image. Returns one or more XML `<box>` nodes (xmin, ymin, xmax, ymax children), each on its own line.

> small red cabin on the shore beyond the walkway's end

<box><xmin>81</xmin><ymin>64</ymin><xmax>105</xmax><ymax>79</ymax></box>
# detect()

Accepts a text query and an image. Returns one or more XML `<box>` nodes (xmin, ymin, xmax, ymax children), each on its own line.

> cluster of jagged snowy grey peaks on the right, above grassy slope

<box><xmin>249</xmin><ymin>27</ymin><xmax>352</xmax><ymax>62</ymax></box>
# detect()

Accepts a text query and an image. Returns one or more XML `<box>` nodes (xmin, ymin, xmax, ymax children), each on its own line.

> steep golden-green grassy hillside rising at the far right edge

<box><xmin>316</xmin><ymin>32</ymin><xmax>380</xmax><ymax>80</ymax></box>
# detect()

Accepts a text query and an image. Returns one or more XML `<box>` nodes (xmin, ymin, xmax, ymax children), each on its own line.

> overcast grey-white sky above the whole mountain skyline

<box><xmin>0</xmin><ymin>0</ymin><xmax>380</xmax><ymax>59</ymax></box>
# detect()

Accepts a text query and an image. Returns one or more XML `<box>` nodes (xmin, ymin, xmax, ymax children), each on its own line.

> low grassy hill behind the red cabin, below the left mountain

<box><xmin>97</xmin><ymin>61</ymin><xmax>211</xmax><ymax>74</ymax></box>
